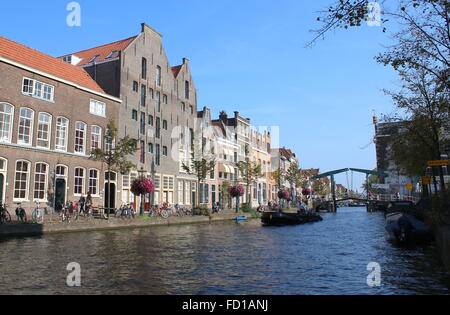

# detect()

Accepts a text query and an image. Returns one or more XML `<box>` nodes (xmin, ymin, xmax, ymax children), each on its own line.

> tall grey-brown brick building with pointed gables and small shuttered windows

<box><xmin>60</xmin><ymin>24</ymin><xmax>197</xmax><ymax>210</ymax></box>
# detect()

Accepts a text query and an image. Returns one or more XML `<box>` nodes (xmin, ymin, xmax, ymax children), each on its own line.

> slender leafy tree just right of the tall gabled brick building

<box><xmin>182</xmin><ymin>137</ymin><xmax>216</xmax><ymax>206</ymax></box>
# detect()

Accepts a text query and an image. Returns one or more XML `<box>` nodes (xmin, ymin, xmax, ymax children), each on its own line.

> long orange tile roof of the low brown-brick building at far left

<box><xmin>0</xmin><ymin>36</ymin><xmax>105</xmax><ymax>93</ymax></box>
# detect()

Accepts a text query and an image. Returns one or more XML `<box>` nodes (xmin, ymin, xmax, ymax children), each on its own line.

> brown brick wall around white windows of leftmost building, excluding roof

<box><xmin>0</xmin><ymin>62</ymin><xmax>119</xmax><ymax>212</ymax></box>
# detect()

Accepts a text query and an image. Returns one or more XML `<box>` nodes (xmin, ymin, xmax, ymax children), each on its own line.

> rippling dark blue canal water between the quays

<box><xmin>0</xmin><ymin>208</ymin><xmax>450</xmax><ymax>295</ymax></box>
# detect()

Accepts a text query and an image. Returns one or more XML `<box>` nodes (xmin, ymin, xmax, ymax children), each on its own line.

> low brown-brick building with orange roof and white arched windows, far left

<box><xmin>0</xmin><ymin>37</ymin><xmax>121</xmax><ymax>213</ymax></box>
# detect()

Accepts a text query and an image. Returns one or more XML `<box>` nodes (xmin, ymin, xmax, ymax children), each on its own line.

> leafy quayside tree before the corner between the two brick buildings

<box><xmin>90</xmin><ymin>121</ymin><xmax>137</xmax><ymax>218</ymax></box>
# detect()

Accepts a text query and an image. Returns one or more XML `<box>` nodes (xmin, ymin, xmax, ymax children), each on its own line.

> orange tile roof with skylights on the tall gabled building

<box><xmin>60</xmin><ymin>36</ymin><xmax>137</xmax><ymax>67</ymax></box>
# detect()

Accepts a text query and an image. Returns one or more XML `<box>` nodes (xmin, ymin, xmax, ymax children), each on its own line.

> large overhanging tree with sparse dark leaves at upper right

<box><xmin>313</xmin><ymin>0</ymin><xmax>450</xmax><ymax>183</ymax></box>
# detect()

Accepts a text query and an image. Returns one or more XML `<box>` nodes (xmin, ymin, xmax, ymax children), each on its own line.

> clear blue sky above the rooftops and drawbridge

<box><xmin>0</xmin><ymin>0</ymin><xmax>397</xmax><ymax>190</ymax></box>
